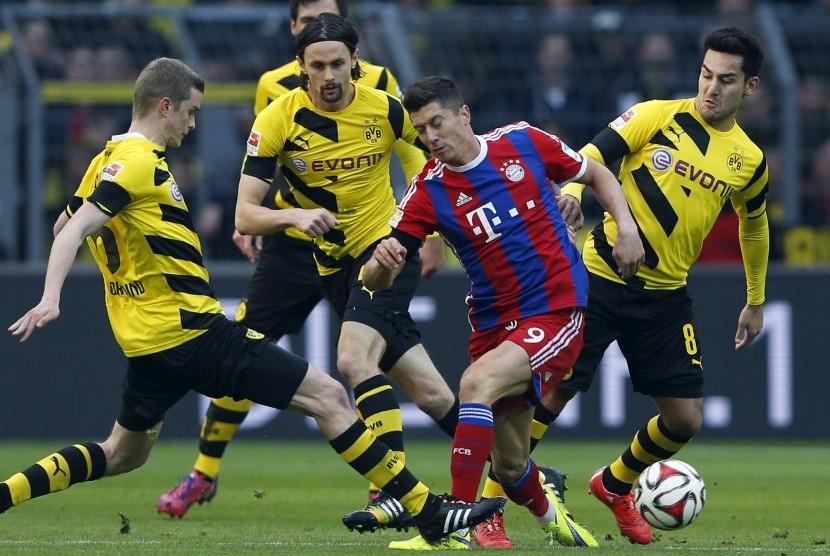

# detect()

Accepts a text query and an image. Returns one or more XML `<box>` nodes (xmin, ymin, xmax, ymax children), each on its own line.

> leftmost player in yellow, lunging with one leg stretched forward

<box><xmin>0</xmin><ymin>58</ymin><xmax>503</xmax><ymax>541</ymax></box>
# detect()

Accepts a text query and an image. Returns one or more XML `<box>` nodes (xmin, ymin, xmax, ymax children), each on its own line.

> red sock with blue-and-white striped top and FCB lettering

<box><xmin>450</xmin><ymin>403</ymin><xmax>493</xmax><ymax>502</ymax></box>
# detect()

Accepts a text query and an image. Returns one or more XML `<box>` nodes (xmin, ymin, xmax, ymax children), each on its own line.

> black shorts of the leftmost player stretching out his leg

<box><xmin>118</xmin><ymin>315</ymin><xmax>308</xmax><ymax>431</ymax></box>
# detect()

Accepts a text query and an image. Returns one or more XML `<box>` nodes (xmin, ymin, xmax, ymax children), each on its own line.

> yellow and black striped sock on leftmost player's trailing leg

<box><xmin>0</xmin><ymin>443</ymin><xmax>107</xmax><ymax>513</ymax></box>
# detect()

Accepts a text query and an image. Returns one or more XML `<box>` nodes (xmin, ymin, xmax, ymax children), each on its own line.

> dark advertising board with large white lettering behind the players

<box><xmin>0</xmin><ymin>265</ymin><xmax>830</xmax><ymax>440</ymax></box>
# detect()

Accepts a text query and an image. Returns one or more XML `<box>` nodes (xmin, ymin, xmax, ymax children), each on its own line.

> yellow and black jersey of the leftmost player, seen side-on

<box><xmin>66</xmin><ymin>133</ymin><xmax>222</xmax><ymax>357</ymax></box>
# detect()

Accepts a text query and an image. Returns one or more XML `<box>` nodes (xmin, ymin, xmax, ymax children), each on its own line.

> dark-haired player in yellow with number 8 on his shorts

<box><xmin>545</xmin><ymin>28</ymin><xmax>769</xmax><ymax>544</ymax></box>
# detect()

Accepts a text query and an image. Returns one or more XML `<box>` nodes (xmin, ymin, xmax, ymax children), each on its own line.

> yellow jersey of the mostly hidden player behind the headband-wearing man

<box><xmin>254</xmin><ymin>60</ymin><xmax>427</xmax><ymax>241</ymax></box>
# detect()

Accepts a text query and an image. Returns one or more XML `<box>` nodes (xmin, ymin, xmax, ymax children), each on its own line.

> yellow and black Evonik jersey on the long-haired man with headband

<box><xmin>242</xmin><ymin>84</ymin><xmax>420</xmax><ymax>275</ymax></box>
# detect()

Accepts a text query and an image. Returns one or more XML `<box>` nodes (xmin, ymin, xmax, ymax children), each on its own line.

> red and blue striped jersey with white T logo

<box><xmin>390</xmin><ymin>122</ymin><xmax>588</xmax><ymax>330</ymax></box>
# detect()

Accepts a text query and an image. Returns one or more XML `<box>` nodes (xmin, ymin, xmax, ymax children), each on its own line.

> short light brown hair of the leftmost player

<box><xmin>133</xmin><ymin>58</ymin><xmax>205</xmax><ymax>118</ymax></box>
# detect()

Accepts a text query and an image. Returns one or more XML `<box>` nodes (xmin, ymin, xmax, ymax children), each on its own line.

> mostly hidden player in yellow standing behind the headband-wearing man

<box><xmin>156</xmin><ymin>0</ymin><xmax>446</xmax><ymax>526</ymax></box>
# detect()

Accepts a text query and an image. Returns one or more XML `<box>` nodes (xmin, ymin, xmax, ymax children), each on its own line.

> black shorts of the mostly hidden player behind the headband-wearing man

<box><xmin>235</xmin><ymin>234</ymin><xmax>325</xmax><ymax>340</ymax></box>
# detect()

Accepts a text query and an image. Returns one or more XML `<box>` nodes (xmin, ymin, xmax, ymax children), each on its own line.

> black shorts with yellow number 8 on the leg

<box><xmin>559</xmin><ymin>272</ymin><xmax>703</xmax><ymax>398</ymax></box>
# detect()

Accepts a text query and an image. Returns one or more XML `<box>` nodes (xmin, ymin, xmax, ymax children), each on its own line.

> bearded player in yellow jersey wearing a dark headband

<box><xmin>236</xmin><ymin>13</ymin><xmax>474</xmax><ymax>531</ymax></box>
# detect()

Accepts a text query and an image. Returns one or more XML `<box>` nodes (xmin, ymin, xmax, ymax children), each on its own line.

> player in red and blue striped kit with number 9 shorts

<box><xmin>364</xmin><ymin>77</ymin><xmax>644</xmax><ymax>549</ymax></box>
